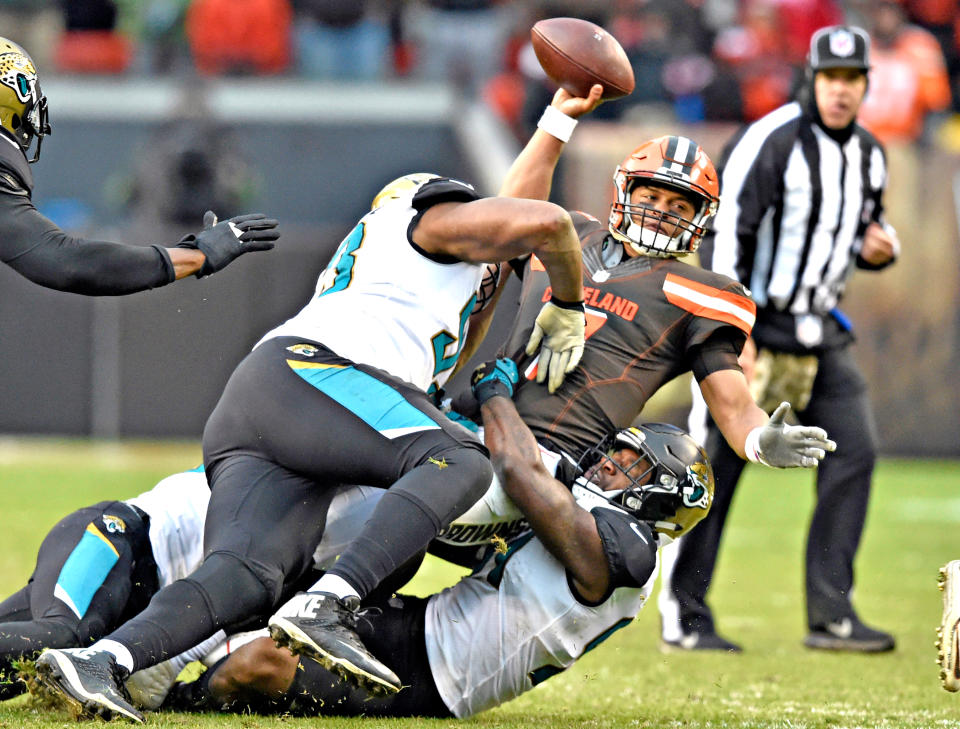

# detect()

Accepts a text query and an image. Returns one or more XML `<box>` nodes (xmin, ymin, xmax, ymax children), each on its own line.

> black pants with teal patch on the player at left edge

<box><xmin>0</xmin><ymin>501</ymin><xmax>159</xmax><ymax>700</ymax></box>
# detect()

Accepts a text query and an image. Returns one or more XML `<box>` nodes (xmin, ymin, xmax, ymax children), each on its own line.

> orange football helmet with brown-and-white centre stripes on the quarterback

<box><xmin>610</xmin><ymin>136</ymin><xmax>720</xmax><ymax>258</ymax></box>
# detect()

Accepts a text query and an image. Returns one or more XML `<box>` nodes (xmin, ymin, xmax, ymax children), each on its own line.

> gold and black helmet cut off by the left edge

<box><xmin>0</xmin><ymin>38</ymin><xmax>50</xmax><ymax>162</ymax></box>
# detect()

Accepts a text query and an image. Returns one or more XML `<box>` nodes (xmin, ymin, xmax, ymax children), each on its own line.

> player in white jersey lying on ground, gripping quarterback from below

<box><xmin>154</xmin><ymin>360</ymin><xmax>713</xmax><ymax>718</ymax></box>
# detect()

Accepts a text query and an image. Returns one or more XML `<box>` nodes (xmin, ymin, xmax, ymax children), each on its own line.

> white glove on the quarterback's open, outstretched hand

<box><xmin>744</xmin><ymin>402</ymin><xmax>837</xmax><ymax>468</ymax></box>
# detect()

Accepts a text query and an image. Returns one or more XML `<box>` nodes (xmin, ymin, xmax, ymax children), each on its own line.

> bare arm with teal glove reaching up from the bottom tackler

<box><xmin>471</xmin><ymin>359</ymin><xmax>610</xmax><ymax>600</ymax></box>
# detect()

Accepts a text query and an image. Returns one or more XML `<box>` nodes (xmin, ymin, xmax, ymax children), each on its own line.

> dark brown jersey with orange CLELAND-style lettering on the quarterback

<box><xmin>506</xmin><ymin>213</ymin><xmax>756</xmax><ymax>457</ymax></box>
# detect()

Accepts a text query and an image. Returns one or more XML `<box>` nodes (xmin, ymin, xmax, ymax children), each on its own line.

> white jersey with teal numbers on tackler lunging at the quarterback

<box><xmin>260</xmin><ymin>178</ymin><xmax>486</xmax><ymax>391</ymax></box>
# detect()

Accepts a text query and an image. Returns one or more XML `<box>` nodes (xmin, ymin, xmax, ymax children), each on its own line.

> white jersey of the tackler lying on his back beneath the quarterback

<box><xmin>426</xmin><ymin>512</ymin><xmax>657</xmax><ymax>718</ymax></box>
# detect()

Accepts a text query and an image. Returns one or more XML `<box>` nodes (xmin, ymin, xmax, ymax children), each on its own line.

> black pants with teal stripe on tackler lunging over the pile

<box><xmin>107</xmin><ymin>337</ymin><xmax>492</xmax><ymax>669</ymax></box>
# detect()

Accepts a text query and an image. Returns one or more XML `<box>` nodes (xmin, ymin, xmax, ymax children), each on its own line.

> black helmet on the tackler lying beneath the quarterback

<box><xmin>572</xmin><ymin>423</ymin><xmax>714</xmax><ymax>539</ymax></box>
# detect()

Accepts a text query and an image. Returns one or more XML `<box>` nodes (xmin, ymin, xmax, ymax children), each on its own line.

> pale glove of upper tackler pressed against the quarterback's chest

<box><xmin>527</xmin><ymin>301</ymin><xmax>586</xmax><ymax>394</ymax></box>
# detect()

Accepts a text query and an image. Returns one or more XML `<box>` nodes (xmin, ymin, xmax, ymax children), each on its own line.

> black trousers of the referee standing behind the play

<box><xmin>671</xmin><ymin>347</ymin><xmax>877</xmax><ymax>634</ymax></box>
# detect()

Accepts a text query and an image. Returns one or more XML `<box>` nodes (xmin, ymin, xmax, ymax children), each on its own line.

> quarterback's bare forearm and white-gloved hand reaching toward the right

<box><xmin>700</xmin><ymin>370</ymin><xmax>837</xmax><ymax>468</ymax></box>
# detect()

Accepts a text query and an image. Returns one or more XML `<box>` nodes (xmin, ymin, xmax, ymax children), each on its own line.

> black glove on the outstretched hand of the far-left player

<box><xmin>177</xmin><ymin>210</ymin><xmax>280</xmax><ymax>278</ymax></box>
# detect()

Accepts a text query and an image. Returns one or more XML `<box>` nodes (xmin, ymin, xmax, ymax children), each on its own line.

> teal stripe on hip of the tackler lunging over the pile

<box><xmin>293</xmin><ymin>367</ymin><xmax>437</xmax><ymax>432</ymax></box>
